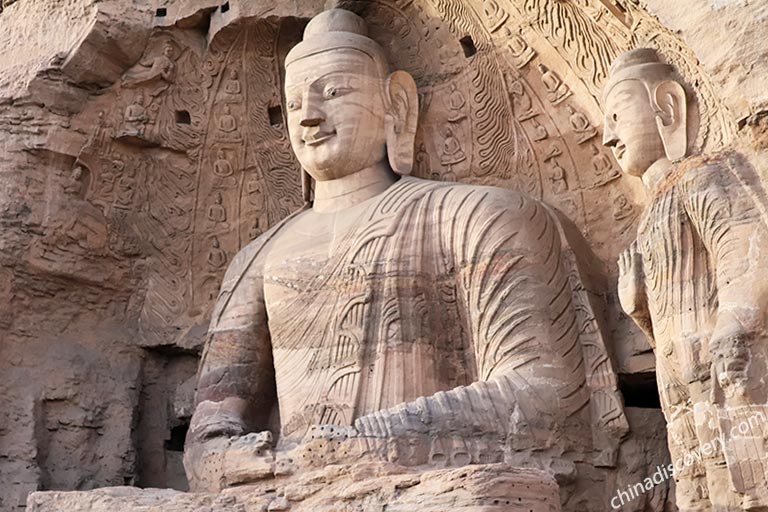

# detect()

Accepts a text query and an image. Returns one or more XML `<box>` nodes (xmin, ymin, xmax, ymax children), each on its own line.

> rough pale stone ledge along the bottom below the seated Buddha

<box><xmin>27</xmin><ymin>464</ymin><xmax>560</xmax><ymax>512</ymax></box>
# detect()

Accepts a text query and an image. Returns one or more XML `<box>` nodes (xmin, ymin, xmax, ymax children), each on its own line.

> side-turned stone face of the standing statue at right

<box><xmin>603</xmin><ymin>80</ymin><xmax>666</xmax><ymax>177</ymax></box>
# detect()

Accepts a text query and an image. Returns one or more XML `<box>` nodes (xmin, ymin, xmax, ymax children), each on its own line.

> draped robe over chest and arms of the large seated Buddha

<box><xmin>197</xmin><ymin>178</ymin><xmax>623</xmax><ymax>452</ymax></box>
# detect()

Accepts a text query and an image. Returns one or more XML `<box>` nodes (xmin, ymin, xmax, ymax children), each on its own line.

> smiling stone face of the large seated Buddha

<box><xmin>285</xmin><ymin>49</ymin><xmax>387</xmax><ymax>181</ymax></box>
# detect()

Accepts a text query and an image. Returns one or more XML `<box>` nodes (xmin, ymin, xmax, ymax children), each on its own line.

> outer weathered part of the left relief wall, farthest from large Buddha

<box><xmin>71</xmin><ymin>32</ymin><xmax>205</xmax><ymax>337</ymax></box>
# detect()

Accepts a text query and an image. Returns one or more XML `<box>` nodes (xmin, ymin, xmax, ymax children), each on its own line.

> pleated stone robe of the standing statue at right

<box><xmin>637</xmin><ymin>155</ymin><xmax>768</xmax><ymax>509</ymax></box>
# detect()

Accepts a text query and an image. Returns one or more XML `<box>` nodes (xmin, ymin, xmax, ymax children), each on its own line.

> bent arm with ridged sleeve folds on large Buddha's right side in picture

<box><xmin>355</xmin><ymin>189</ymin><xmax>583</xmax><ymax>436</ymax></box>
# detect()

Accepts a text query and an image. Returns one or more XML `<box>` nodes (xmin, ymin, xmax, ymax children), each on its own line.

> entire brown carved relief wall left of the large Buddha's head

<box><xmin>70</xmin><ymin>22</ymin><xmax>301</xmax><ymax>344</ymax></box>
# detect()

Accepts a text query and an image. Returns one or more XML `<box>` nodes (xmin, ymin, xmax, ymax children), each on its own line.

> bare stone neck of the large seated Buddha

<box><xmin>312</xmin><ymin>160</ymin><xmax>398</xmax><ymax>213</ymax></box>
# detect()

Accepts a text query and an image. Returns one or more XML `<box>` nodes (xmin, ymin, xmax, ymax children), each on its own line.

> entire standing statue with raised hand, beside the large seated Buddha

<box><xmin>603</xmin><ymin>49</ymin><xmax>768</xmax><ymax>511</ymax></box>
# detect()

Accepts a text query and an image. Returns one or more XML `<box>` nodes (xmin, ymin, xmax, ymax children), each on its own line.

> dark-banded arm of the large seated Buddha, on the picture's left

<box><xmin>187</xmin><ymin>247</ymin><xmax>276</xmax><ymax>443</ymax></box>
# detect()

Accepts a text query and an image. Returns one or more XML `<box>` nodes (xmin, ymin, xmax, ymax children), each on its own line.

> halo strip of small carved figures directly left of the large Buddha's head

<box><xmin>191</xmin><ymin>22</ymin><xmax>301</xmax><ymax>316</ymax></box>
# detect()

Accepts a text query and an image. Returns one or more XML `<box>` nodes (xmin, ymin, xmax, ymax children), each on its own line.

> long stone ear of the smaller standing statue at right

<box><xmin>653</xmin><ymin>80</ymin><xmax>688</xmax><ymax>161</ymax></box>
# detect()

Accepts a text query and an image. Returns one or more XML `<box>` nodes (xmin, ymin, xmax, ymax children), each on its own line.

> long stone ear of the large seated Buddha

<box><xmin>385</xmin><ymin>71</ymin><xmax>419</xmax><ymax>175</ymax></box>
